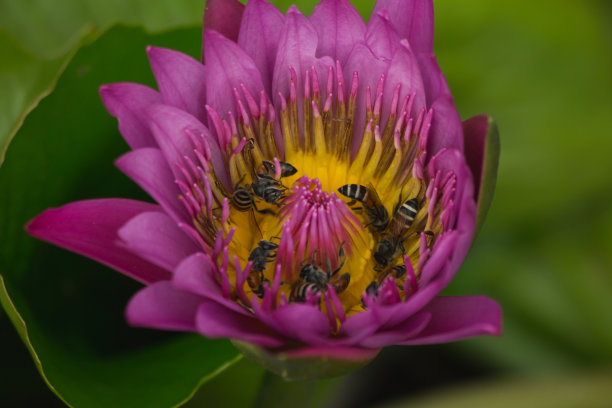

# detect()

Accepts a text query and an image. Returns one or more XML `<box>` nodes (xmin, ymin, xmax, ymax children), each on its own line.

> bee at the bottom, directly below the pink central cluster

<box><xmin>289</xmin><ymin>247</ymin><xmax>351</xmax><ymax>302</ymax></box>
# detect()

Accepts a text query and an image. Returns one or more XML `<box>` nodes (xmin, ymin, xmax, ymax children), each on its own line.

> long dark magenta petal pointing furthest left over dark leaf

<box><xmin>26</xmin><ymin>198</ymin><xmax>171</xmax><ymax>284</ymax></box>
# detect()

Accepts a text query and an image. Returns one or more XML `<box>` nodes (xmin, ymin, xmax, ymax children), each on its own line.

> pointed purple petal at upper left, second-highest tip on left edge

<box><xmin>147</xmin><ymin>47</ymin><xmax>206</xmax><ymax>123</ymax></box>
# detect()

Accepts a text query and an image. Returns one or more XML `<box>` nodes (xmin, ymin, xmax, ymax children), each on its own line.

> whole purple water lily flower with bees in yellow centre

<box><xmin>27</xmin><ymin>0</ymin><xmax>501</xmax><ymax>380</ymax></box>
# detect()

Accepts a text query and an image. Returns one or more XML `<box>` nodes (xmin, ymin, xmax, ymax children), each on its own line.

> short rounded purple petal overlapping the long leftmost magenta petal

<box><xmin>118</xmin><ymin>212</ymin><xmax>198</xmax><ymax>271</ymax></box>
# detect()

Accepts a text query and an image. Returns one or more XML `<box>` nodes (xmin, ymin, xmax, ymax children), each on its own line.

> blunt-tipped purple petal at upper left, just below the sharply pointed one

<box><xmin>100</xmin><ymin>82</ymin><xmax>162</xmax><ymax>149</ymax></box>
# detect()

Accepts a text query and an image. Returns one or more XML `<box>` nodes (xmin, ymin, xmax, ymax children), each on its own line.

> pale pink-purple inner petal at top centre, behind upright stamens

<box><xmin>272</xmin><ymin>6</ymin><xmax>334</xmax><ymax>117</ymax></box>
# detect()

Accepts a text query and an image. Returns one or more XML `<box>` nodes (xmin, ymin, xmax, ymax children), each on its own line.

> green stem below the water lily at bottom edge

<box><xmin>253</xmin><ymin>370</ymin><xmax>316</xmax><ymax>408</ymax></box>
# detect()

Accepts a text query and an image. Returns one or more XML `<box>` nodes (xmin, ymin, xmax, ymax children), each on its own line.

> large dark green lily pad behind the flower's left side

<box><xmin>0</xmin><ymin>27</ymin><xmax>237</xmax><ymax>407</ymax></box>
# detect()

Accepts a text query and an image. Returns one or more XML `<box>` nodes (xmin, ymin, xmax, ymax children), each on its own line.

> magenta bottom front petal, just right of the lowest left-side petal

<box><xmin>196</xmin><ymin>299</ymin><xmax>285</xmax><ymax>347</ymax></box>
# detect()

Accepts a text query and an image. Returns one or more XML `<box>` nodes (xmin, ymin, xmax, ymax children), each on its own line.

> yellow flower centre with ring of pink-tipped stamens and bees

<box><xmin>177</xmin><ymin>63</ymin><xmax>456</xmax><ymax>333</ymax></box>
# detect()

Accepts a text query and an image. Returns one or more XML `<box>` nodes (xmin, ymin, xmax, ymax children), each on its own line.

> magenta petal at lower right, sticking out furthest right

<box><xmin>399</xmin><ymin>296</ymin><xmax>502</xmax><ymax>345</ymax></box>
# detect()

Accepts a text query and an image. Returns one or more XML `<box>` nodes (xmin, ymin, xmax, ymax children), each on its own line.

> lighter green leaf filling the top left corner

<box><xmin>0</xmin><ymin>0</ymin><xmax>203</xmax><ymax>165</ymax></box>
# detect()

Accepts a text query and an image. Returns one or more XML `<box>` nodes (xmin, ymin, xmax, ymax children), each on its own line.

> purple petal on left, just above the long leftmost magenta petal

<box><xmin>115</xmin><ymin>147</ymin><xmax>190</xmax><ymax>222</ymax></box>
